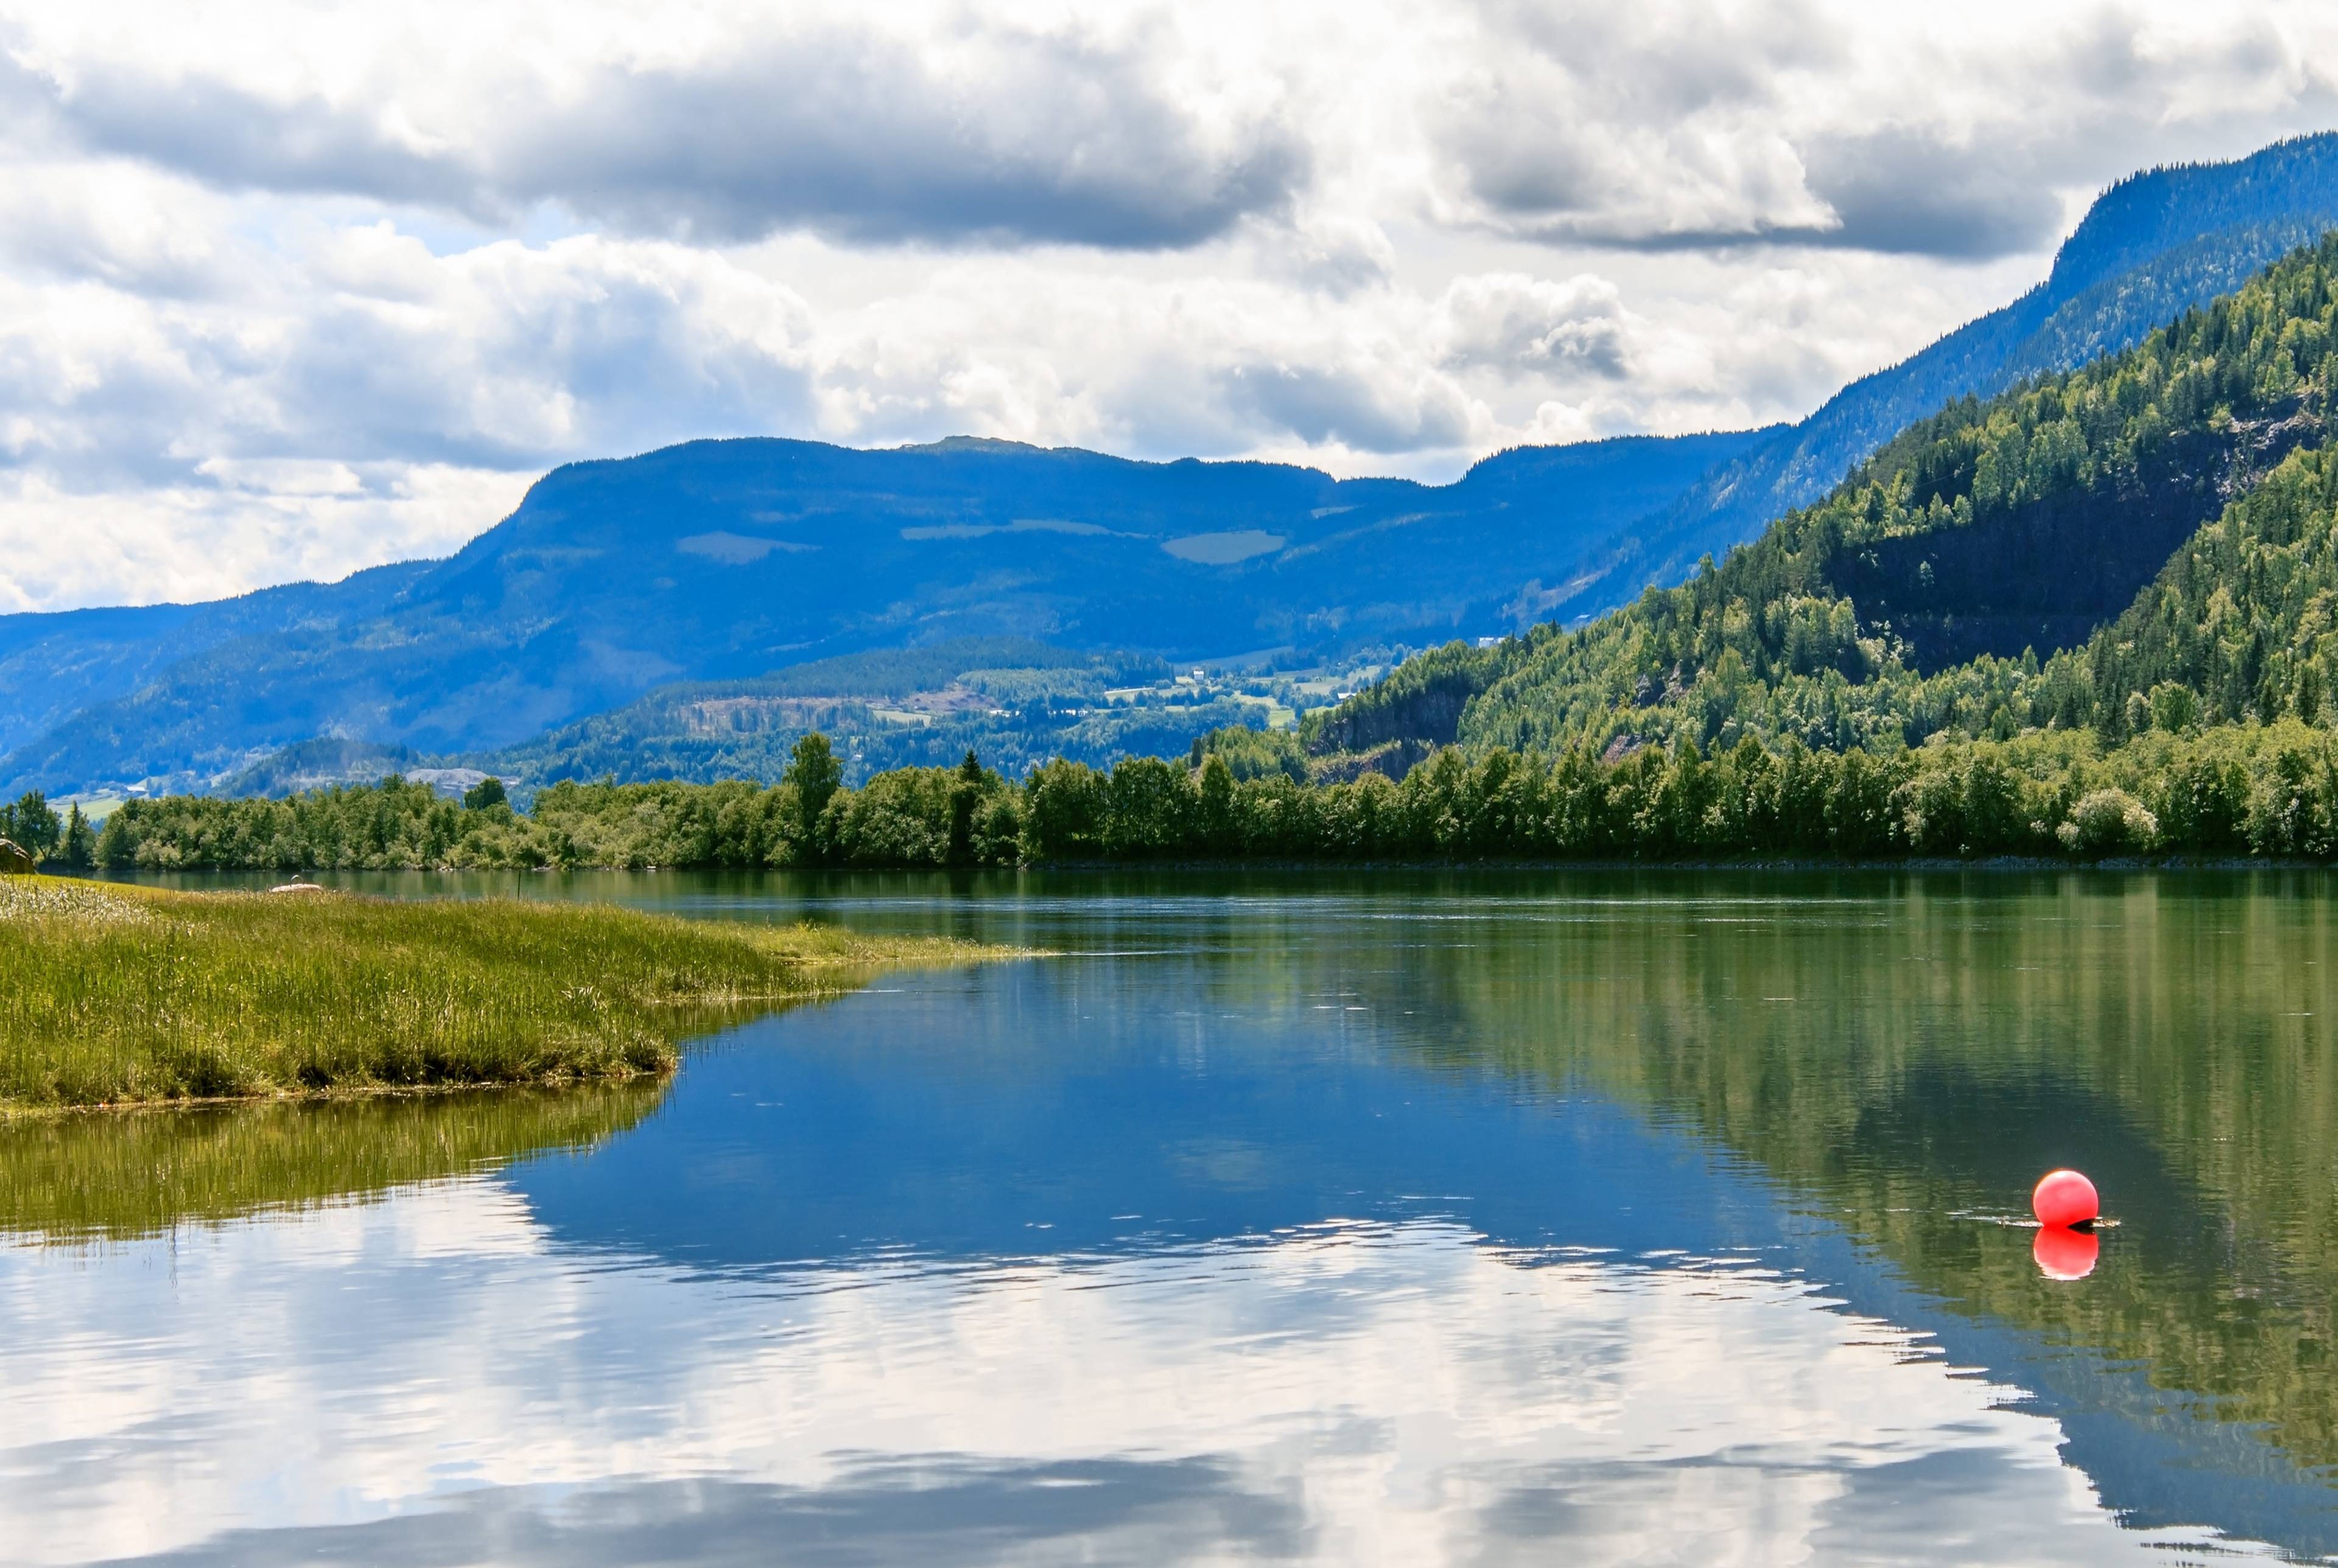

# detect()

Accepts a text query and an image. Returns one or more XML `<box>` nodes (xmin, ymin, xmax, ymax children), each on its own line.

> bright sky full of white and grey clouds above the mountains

<box><xmin>0</xmin><ymin>0</ymin><xmax>2338</xmax><ymax>612</ymax></box>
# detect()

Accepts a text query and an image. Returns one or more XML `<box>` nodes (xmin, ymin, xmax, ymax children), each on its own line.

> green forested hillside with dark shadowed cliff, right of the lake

<box><xmin>1311</xmin><ymin>236</ymin><xmax>2338</xmax><ymax>766</ymax></box>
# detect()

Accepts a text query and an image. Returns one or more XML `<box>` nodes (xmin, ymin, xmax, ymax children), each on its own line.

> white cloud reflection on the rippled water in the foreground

<box><xmin>0</xmin><ymin>1180</ymin><xmax>2263</xmax><ymax>1563</ymax></box>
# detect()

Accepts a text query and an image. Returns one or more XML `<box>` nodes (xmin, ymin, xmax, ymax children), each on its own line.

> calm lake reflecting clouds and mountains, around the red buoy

<box><xmin>0</xmin><ymin>872</ymin><xmax>2338</xmax><ymax>1566</ymax></box>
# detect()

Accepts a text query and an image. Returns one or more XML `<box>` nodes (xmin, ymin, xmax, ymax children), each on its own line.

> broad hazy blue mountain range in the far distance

<box><xmin>0</xmin><ymin>432</ymin><xmax>1758</xmax><ymax>790</ymax></box>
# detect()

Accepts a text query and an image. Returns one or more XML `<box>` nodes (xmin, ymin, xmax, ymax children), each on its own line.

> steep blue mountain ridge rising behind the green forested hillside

<box><xmin>1550</xmin><ymin>133</ymin><xmax>2338</xmax><ymax>619</ymax></box>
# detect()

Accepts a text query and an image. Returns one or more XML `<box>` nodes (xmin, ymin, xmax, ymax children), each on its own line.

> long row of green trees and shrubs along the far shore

<box><xmin>73</xmin><ymin>719</ymin><xmax>2338</xmax><ymax>872</ymax></box>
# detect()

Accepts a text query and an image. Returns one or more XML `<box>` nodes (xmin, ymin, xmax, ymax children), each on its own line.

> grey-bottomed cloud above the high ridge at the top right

<box><xmin>1433</xmin><ymin>0</ymin><xmax>2338</xmax><ymax>259</ymax></box>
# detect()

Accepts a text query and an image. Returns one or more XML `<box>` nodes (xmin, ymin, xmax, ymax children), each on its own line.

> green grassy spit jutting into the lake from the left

<box><xmin>0</xmin><ymin>877</ymin><xmax>996</xmax><ymax>1110</ymax></box>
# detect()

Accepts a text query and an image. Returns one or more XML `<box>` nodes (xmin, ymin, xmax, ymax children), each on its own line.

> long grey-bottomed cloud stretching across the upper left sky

<box><xmin>19</xmin><ymin>23</ymin><xmax>1307</xmax><ymax>248</ymax></box>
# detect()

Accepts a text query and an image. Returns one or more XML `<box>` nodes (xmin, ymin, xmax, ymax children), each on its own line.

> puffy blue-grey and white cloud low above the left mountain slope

<box><xmin>0</xmin><ymin>205</ymin><xmax>827</xmax><ymax>491</ymax></box>
